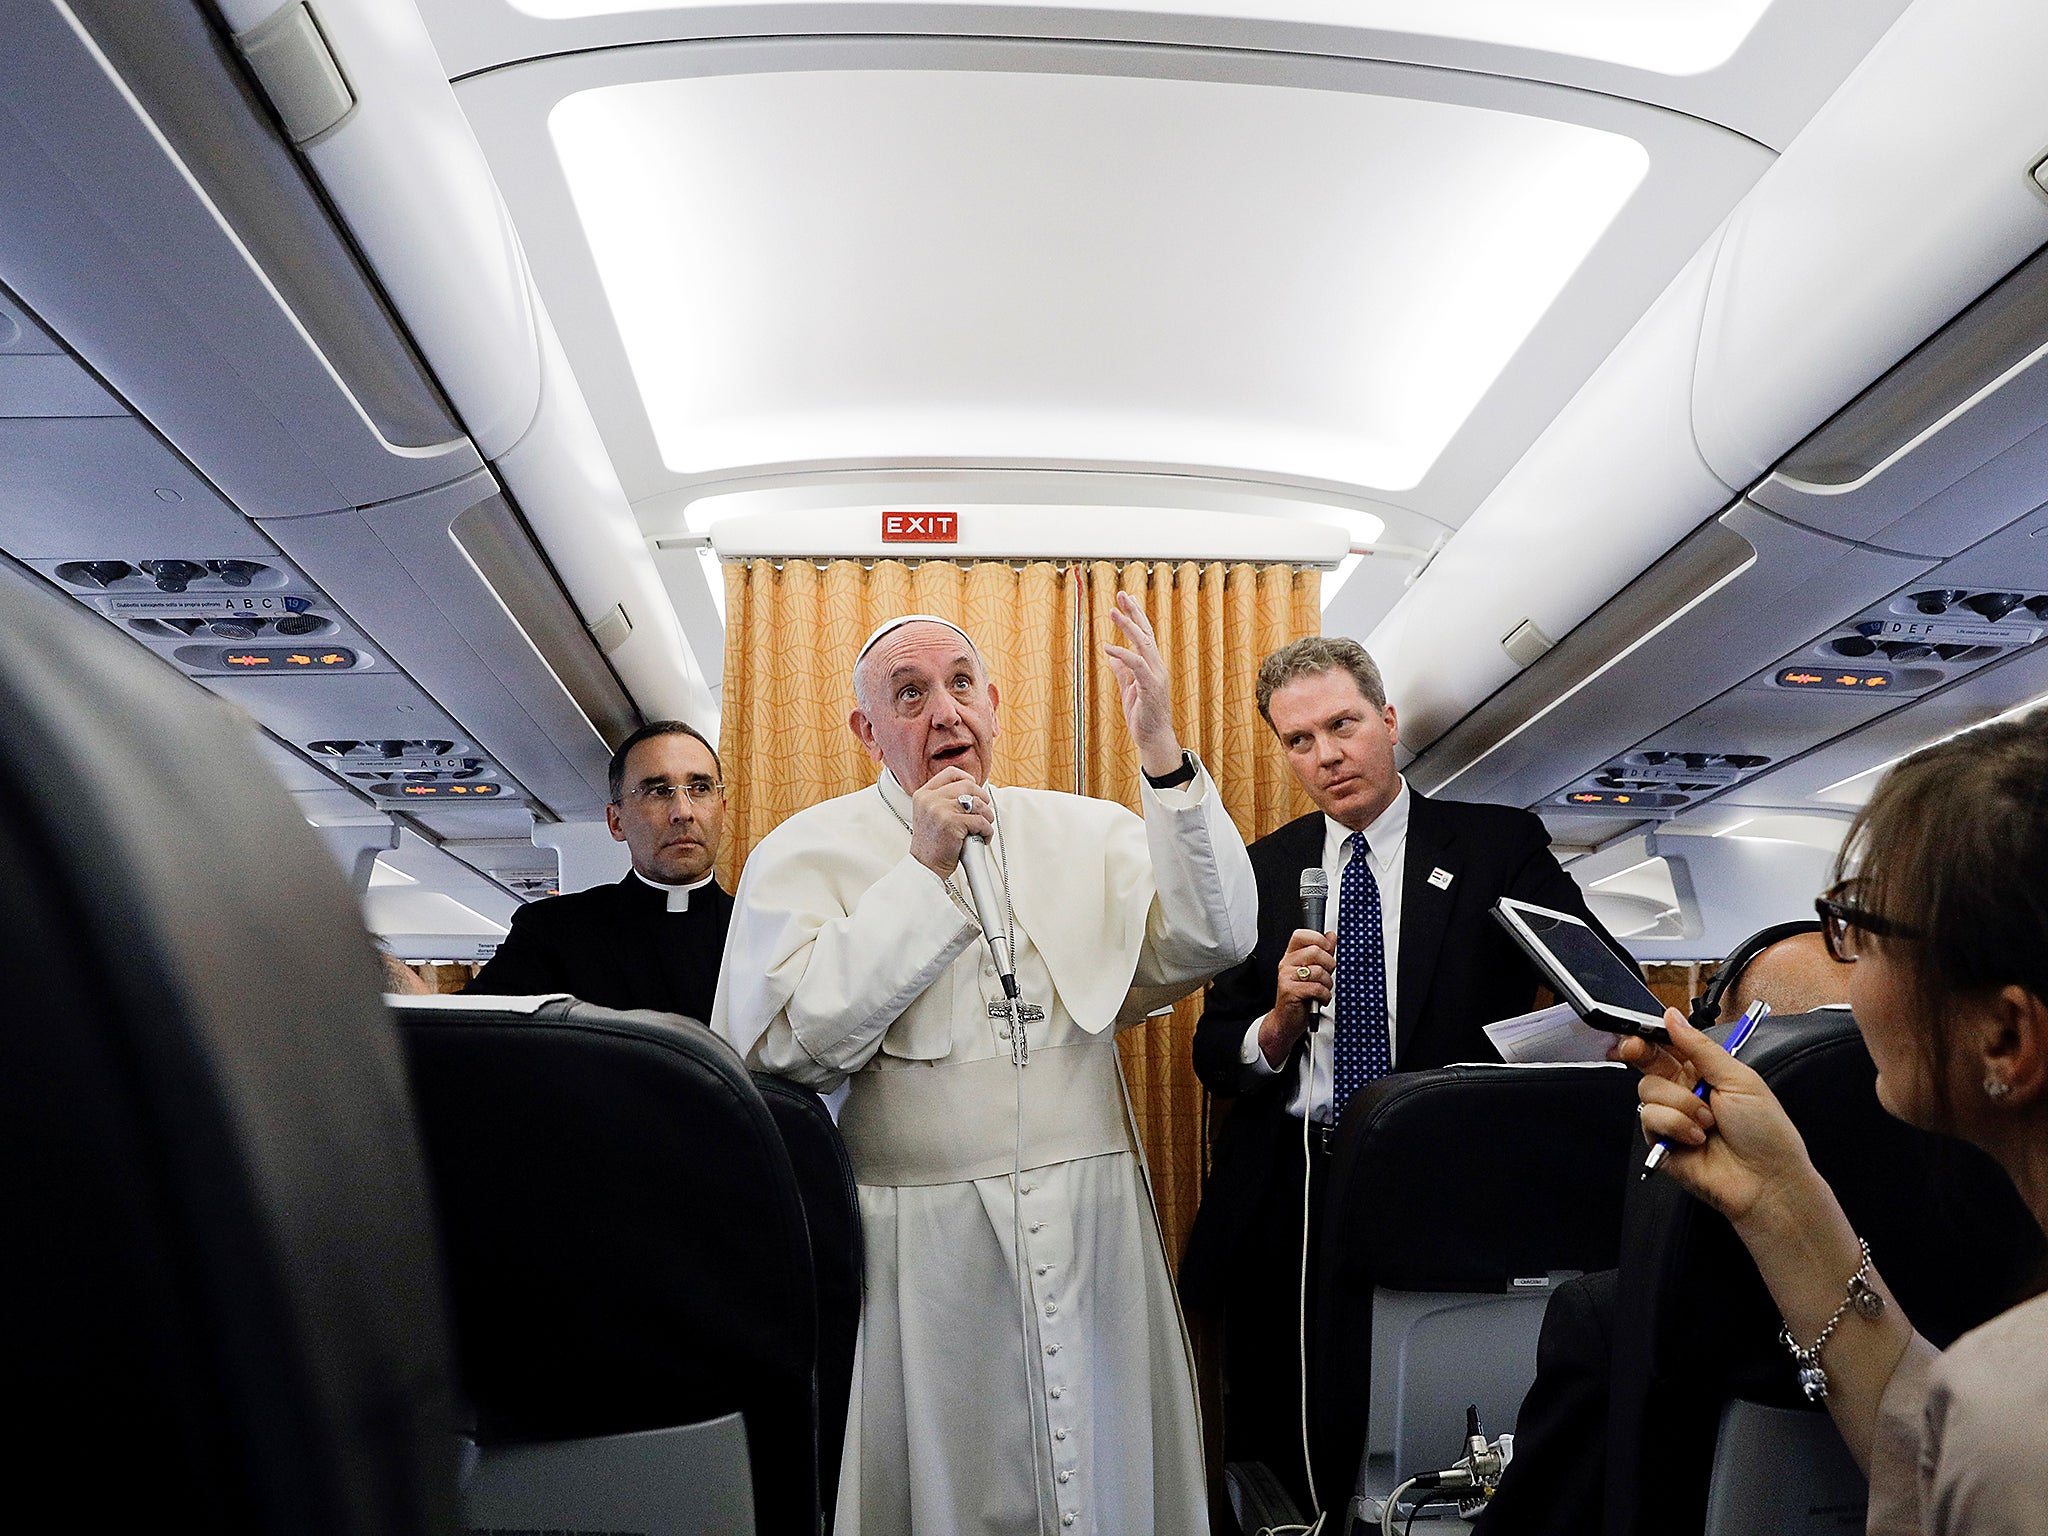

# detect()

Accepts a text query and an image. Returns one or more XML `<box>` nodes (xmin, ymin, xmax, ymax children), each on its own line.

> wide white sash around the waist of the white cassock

<box><xmin>840</xmin><ymin>1040</ymin><xmax>1130</xmax><ymax>1186</ymax></box>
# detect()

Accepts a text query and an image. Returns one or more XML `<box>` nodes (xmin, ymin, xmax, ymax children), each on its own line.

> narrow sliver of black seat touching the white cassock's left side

<box><xmin>754</xmin><ymin>1071</ymin><xmax>866</xmax><ymax>1528</ymax></box>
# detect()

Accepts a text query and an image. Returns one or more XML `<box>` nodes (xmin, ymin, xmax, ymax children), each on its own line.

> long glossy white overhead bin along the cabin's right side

<box><xmin>1368</xmin><ymin>0</ymin><xmax>2048</xmax><ymax>750</ymax></box>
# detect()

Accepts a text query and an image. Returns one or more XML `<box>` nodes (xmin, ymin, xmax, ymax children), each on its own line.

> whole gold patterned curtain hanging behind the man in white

<box><xmin>719</xmin><ymin>559</ymin><xmax>1321</xmax><ymax>1264</ymax></box>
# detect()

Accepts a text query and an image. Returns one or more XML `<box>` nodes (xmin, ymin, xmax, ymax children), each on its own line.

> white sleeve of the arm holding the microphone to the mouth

<box><xmin>721</xmin><ymin>854</ymin><xmax>981</xmax><ymax>1092</ymax></box>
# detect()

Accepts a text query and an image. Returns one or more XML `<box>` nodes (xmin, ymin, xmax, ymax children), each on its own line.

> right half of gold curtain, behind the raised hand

<box><xmin>1081</xmin><ymin>561</ymin><xmax>1323</xmax><ymax>1268</ymax></box>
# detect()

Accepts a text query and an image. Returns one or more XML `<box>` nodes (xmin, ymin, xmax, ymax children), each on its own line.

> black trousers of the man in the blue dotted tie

<box><xmin>1223</xmin><ymin>1126</ymin><xmax>1327</xmax><ymax>1513</ymax></box>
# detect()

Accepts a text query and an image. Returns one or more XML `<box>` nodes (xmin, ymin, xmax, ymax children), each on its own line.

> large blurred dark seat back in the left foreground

<box><xmin>0</xmin><ymin>582</ymin><xmax>455</xmax><ymax>1536</ymax></box>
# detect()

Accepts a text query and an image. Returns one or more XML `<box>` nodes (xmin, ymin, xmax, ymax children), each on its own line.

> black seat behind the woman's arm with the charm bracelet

<box><xmin>1606</xmin><ymin>1010</ymin><xmax>2048</xmax><ymax>1536</ymax></box>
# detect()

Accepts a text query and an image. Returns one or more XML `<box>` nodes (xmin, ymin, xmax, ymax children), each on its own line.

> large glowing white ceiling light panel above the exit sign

<box><xmin>549</xmin><ymin>70</ymin><xmax>1649</xmax><ymax>489</ymax></box>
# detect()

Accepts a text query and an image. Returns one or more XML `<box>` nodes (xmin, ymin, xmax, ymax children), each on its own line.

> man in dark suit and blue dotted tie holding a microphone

<box><xmin>1180</xmin><ymin>637</ymin><xmax>1620</xmax><ymax>1495</ymax></box>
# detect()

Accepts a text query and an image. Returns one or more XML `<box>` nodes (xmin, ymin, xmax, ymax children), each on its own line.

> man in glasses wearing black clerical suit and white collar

<box><xmin>463</xmin><ymin>721</ymin><xmax>733</xmax><ymax>1020</ymax></box>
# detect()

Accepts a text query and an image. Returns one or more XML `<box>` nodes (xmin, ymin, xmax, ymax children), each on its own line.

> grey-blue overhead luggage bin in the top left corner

<box><xmin>0</xmin><ymin>0</ymin><xmax>481</xmax><ymax>512</ymax></box>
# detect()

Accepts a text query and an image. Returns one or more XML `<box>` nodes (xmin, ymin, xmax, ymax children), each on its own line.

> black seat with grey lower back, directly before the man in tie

<box><xmin>1309</xmin><ymin>1065</ymin><xmax>1636</xmax><ymax>1507</ymax></box>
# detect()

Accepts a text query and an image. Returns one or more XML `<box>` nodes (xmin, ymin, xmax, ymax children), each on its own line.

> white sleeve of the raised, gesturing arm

<box><xmin>1133</xmin><ymin>766</ymin><xmax>1260</xmax><ymax>987</ymax></box>
